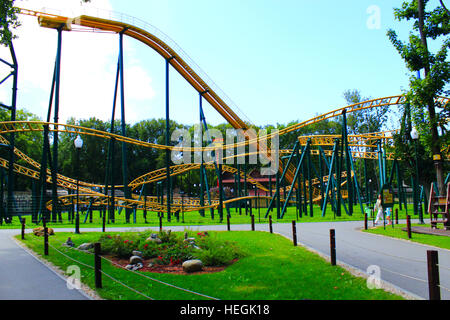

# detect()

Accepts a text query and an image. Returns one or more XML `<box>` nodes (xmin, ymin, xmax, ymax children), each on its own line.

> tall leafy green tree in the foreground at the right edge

<box><xmin>387</xmin><ymin>0</ymin><xmax>450</xmax><ymax>193</ymax></box>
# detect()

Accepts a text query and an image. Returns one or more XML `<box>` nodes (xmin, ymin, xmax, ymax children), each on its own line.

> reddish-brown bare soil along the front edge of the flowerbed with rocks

<box><xmin>105</xmin><ymin>256</ymin><xmax>238</xmax><ymax>274</ymax></box>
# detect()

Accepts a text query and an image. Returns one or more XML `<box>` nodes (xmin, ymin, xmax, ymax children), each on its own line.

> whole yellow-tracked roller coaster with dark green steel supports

<box><xmin>0</xmin><ymin>9</ymin><xmax>449</xmax><ymax>224</ymax></box>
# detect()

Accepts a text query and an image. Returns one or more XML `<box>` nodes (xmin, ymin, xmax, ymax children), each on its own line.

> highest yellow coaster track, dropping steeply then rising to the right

<box><xmin>15</xmin><ymin>9</ymin><xmax>448</xmax><ymax>188</ymax></box>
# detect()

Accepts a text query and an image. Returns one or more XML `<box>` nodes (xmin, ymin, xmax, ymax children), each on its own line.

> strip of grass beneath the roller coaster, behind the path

<box><xmin>0</xmin><ymin>205</ymin><xmax>415</xmax><ymax>229</ymax></box>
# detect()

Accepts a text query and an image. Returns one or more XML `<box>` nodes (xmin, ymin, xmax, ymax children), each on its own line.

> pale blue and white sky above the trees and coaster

<box><xmin>0</xmin><ymin>0</ymin><xmax>444</xmax><ymax>125</ymax></box>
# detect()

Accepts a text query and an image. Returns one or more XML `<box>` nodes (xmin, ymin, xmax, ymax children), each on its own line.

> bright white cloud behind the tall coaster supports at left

<box><xmin>0</xmin><ymin>0</ymin><xmax>155</xmax><ymax>122</ymax></box>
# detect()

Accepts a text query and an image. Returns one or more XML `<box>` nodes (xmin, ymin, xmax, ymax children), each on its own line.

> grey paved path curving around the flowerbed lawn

<box><xmin>0</xmin><ymin>221</ymin><xmax>450</xmax><ymax>300</ymax></box>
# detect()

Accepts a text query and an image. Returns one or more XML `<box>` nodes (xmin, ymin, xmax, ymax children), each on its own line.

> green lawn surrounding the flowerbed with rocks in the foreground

<box><xmin>17</xmin><ymin>231</ymin><xmax>402</xmax><ymax>300</ymax></box>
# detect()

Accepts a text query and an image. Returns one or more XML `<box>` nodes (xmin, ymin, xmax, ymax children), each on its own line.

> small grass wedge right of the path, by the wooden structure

<box><xmin>364</xmin><ymin>224</ymin><xmax>450</xmax><ymax>250</ymax></box>
